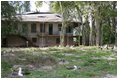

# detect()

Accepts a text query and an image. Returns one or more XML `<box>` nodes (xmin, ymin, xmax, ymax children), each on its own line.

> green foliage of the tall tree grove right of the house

<box><xmin>51</xmin><ymin>1</ymin><xmax>117</xmax><ymax>45</ymax></box>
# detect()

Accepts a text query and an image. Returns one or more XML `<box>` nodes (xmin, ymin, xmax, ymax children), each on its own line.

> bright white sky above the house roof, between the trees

<box><xmin>30</xmin><ymin>1</ymin><xmax>49</xmax><ymax>12</ymax></box>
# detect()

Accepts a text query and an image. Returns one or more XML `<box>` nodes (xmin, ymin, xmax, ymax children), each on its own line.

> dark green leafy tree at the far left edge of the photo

<box><xmin>1</xmin><ymin>1</ymin><xmax>17</xmax><ymax>39</ymax></box>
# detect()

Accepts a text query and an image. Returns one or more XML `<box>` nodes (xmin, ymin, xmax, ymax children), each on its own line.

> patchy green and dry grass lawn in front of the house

<box><xmin>1</xmin><ymin>46</ymin><xmax>117</xmax><ymax>78</ymax></box>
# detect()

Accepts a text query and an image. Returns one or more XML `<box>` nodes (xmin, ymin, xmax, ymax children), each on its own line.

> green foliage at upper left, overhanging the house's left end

<box><xmin>1</xmin><ymin>1</ymin><xmax>30</xmax><ymax>40</ymax></box>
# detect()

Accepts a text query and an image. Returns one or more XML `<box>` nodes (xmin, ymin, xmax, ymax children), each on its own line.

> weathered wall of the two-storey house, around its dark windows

<box><xmin>8</xmin><ymin>22</ymin><xmax>73</xmax><ymax>46</ymax></box>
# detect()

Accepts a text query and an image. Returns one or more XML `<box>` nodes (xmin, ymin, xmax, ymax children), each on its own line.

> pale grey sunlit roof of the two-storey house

<box><xmin>18</xmin><ymin>12</ymin><xmax>62</xmax><ymax>22</ymax></box>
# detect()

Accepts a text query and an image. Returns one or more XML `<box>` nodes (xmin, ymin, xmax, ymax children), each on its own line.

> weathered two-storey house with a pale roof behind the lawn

<box><xmin>1</xmin><ymin>12</ymin><xmax>81</xmax><ymax>47</ymax></box>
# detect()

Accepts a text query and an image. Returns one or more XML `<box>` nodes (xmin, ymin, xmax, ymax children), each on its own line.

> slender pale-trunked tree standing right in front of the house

<box><xmin>52</xmin><ymin>1</ymin><xmax>73</xmax><ymax>47</ymax></box>
